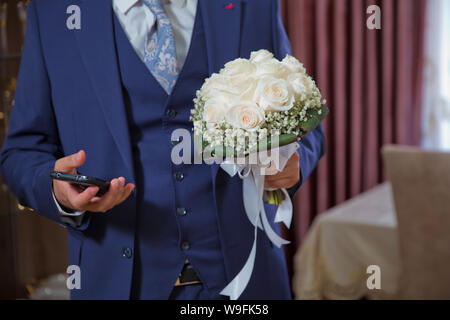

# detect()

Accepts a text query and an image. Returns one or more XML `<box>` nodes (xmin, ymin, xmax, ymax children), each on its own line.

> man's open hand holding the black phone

<box><xmin>53</xmin><ymin>150</ymin><xmax>135</xmax><ymax>212</ymax></box>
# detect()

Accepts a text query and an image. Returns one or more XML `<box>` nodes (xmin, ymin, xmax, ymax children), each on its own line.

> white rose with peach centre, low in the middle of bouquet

<box><xmin>226</xmin><ymin>101</ymin><xmax>264</xmax><ymax>131</ymax></box>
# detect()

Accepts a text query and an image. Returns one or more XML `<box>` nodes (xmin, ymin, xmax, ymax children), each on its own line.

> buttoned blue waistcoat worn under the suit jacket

<box><xmin>114</xmin><ymin>10</ymin><xmax>226</xmax><ymax>299</ymax></box>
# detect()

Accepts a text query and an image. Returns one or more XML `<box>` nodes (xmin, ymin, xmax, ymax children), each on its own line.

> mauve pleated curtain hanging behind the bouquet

<box><xmin>281</xmin><ymin>0</ymin><xmax>426</xmax><ymax>276</ymax></box>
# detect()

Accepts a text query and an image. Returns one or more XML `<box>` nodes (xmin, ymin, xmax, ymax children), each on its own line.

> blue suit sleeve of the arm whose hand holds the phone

<box><xmin>0</xmin><ymin>1</ymin><xmax>89</xmax><ymax>230</ymax></box>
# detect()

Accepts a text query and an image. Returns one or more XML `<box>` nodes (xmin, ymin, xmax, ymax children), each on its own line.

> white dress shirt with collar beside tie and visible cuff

<box><xmin>53</xmin><ymin>0</ymin><xmax>198</xmax><ymax>225</ymax></box>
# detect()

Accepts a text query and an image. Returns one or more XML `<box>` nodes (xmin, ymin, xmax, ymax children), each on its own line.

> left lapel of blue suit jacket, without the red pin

<box><xmin>71</xmin><ymin>0</ymin><xmax>134</xmax><ymax>177</ymax></box>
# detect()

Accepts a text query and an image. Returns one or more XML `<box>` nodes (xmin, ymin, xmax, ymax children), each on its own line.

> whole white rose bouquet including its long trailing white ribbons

<box><xmin>191</xmin><ymin>50</ymin><xmax>328</xmax><ymax>299</ymax></box>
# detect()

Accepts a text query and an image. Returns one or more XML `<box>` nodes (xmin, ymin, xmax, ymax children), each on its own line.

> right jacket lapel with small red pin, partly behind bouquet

<box><xmin>198</xmin><ymin>0</ymin><xmax>242</xmax><ymax>180</ymax></box>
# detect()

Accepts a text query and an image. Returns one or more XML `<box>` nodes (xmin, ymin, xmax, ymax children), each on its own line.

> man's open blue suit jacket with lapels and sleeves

<box><xmin>1</xmin><ymin>0</ymin><xmax>324</xmax><ymax>299</ymax></box>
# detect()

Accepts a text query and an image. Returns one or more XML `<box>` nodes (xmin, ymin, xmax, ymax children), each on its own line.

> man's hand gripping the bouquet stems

<box><xmin>264</xmin><ymin>152</ymin><xmax>300</xmax><ymax>189</ymax></box>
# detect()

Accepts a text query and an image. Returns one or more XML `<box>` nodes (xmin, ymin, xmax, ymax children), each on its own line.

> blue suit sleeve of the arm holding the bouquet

<box><xmin>272</xmin><ymin>0</ymin><xmax>325</xmax><ymax>197</ymax></box>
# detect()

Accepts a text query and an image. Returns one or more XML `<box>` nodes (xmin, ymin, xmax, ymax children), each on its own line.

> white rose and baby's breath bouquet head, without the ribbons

<box><xmin>191</xmin><ymin>50</ymin><xmax>328</xmax><ymax>155</ymax></box>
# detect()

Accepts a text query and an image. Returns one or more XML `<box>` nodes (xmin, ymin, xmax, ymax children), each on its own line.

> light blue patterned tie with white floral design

<box><xmin>142</xmin><ymin>0</ymin><xmax>179</xmax><ymax>94</ymax></box>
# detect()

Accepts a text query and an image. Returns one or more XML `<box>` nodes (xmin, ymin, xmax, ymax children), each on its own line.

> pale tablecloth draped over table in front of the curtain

<box><xmin>293</xmin><ymin>183</ymin><xmax>400</xmax><ymax>299</ymax></box>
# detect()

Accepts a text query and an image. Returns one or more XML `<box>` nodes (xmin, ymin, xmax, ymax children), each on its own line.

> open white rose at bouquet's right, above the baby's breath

<box><xmin>254</xmin><ymin>77</ymin><xmax>295</xmax><ymax>111</ymax></box>
